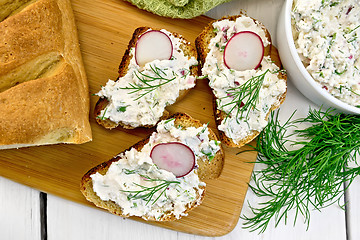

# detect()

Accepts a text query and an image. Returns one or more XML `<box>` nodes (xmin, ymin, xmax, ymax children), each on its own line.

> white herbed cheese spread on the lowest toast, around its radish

<box><xmin>91</xmin><ymin>119</ymin><xmax>220</xmax><ymax>219</ymax></box>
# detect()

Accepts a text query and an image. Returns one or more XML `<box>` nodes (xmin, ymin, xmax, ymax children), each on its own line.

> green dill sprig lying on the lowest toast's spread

<box><xmin>120</xmin><ymin>171</ymin><xmax>180</xmax><ymax>205</ymax></box>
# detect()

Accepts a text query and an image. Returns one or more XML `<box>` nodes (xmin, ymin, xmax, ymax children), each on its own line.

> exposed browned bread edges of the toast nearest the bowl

<box><xmin>195</xmin><ymin>12</ymin><xmax>287</xmax><ymax>147</ymax></box>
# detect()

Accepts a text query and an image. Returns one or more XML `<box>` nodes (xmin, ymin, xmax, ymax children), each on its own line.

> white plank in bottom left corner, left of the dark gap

<box><xmin>0</xmin><ymin>177</ymin><xmax>41</xmax><ymax>240</ymax></box>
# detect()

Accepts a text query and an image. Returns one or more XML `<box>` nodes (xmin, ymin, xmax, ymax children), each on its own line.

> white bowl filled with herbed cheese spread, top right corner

<box><xmin>277</xmin><ymin>0</ymin><xmax>360</xmax><ymax>114</ymax></box>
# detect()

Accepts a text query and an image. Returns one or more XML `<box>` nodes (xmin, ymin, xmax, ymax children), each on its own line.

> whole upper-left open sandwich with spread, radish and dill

<box><xmin>94</xmin><ymin>27</ymin><xmax>198</xmax><ymax>129</ymax></box>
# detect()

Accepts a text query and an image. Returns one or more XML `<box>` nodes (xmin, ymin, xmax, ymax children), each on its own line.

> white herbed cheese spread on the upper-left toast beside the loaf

<box><xmin>96</xmin><ymin>29</ymin><xmax>197</xmax><ymax>127</ymax></box>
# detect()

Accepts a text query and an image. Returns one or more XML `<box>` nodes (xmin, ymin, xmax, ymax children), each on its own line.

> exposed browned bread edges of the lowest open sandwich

<box><xmin>80</xmin><ymin>113</ymin><xmax>224</xmax><ymax>221</ymax></box>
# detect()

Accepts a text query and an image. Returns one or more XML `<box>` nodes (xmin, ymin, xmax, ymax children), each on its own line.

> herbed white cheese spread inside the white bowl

<box><xmin>292</xmin><ymin>0</ymin><xmax>360</xmax><ymax>107</ymax></box>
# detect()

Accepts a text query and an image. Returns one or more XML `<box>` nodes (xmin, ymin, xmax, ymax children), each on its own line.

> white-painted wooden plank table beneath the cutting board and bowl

<box><xmin>0</xmin><ymin>0</ymin><xmax>360</xmax><ymax>240</ymax></box>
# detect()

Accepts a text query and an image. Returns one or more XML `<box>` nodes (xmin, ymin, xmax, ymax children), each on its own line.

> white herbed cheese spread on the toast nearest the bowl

<box><xmin>202</xmin><ymin>16</ymin><xmax>286</xmax><ymax>144</ymax></box>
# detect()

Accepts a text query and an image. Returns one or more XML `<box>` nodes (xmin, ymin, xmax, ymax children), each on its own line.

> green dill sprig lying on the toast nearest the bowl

<box><xmin>221</xmin><ymin>69</ymin><xmax>269</xmax><ymax>122</ymax></box>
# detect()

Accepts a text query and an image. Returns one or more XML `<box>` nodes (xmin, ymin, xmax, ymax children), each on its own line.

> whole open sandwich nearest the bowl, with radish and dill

<box><xmin>195</xmin><ymin>14</ymin><xmax>287</xmax><ymax>147</ymax></box>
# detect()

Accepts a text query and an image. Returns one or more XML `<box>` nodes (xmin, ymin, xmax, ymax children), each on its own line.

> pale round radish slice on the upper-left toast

<box><xmin>135</xmin><ymin>30</ymin><xmax>173</xmax><ymax>66</ymax></box>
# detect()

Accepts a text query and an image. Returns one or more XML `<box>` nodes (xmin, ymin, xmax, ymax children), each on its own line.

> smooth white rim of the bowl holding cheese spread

<box><xmin>284</xmin><ymin>0</ymin><xmax>360</xmax><ymax>114</ymax></box>
